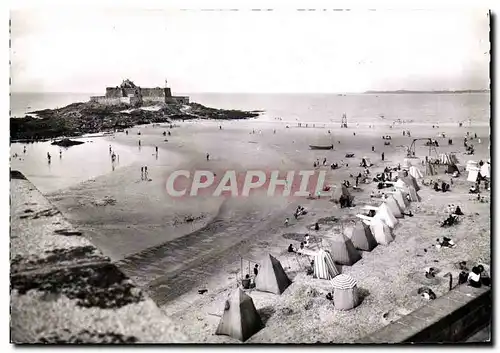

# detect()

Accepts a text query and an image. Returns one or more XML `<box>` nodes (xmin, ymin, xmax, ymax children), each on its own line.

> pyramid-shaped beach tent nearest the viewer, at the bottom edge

<box><xmin>215</xmin><ymin>288</ymin><xmax>264</xmax><ymax>342</ymax></box>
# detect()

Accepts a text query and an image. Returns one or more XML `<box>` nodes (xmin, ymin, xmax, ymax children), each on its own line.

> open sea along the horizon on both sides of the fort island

<box><xmin>10</xmin><ymin>93</ymin><xmax>490</xmax><ymax>126</ymax></box>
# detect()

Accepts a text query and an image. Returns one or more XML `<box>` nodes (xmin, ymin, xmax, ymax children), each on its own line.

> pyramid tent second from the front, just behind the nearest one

<box><xmin>255</xmin><ymin>254</ymin><xmax>292</xmax><ymax>294</ymax></box>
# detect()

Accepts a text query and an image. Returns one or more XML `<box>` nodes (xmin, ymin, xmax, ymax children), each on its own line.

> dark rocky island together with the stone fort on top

<box><xmin>10</xmin><ymin>80</ymin><xmax>259</xmax><ymax>141</ymax></box>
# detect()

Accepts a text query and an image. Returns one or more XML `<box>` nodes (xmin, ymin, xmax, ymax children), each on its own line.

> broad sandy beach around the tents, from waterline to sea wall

<box><xmin>38</xmin><ymin>115</ymin><xmax>490</xmax><ymax>343</ymax></box>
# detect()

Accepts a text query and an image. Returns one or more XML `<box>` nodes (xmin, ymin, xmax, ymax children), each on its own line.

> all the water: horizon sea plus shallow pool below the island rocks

<box><xmin>10</xmin><ymin>93</ymin><xmax>490</xmax><ymax>193</ymax></box>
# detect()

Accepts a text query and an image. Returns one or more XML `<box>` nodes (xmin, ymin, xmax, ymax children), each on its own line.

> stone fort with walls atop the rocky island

<box><xmin>90</xmin><ymin>79</ymin><xmax>189</xmax><ymax>106</ymax></box>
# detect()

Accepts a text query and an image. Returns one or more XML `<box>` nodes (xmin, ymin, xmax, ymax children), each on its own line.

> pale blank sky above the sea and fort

<box><xmin>11</xmin><ymin>7</ymin><xmax>490</xmax><ymax>94</ymax></box>
